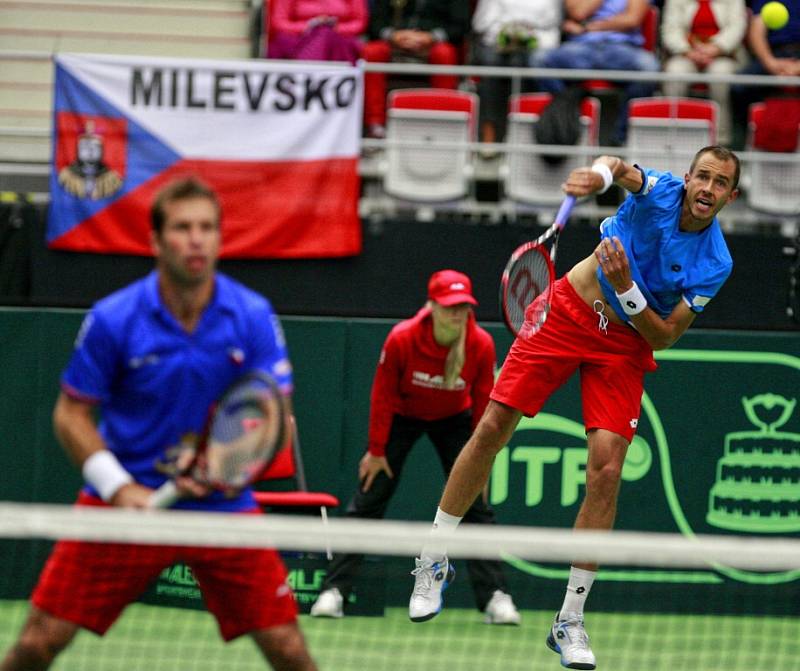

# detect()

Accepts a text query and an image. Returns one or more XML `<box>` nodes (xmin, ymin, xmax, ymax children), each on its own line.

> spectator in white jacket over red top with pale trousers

<box><xmin>661</xmin><ymin>0</ymin><xmax>748</xmax><ymax>145</ymax></box>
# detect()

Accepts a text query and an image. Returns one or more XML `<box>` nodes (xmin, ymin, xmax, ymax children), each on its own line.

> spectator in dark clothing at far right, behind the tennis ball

<box><xmin>731</xmin><ymin>0</ymin><xmax>800</xmax><ymax>149</ymax></box>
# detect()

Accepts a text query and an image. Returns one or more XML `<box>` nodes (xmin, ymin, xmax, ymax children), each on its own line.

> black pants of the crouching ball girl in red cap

<box><xmin>322</xmin><ymin>412</ymin><xmax>507</xmax><ymax>610</ymax></box>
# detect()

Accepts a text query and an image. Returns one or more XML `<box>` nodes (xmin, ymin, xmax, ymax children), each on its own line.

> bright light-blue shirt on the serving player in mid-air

<box><xmin>597</xmin><ymin>166</ymin><xmax>733</xmax><ymax>322</ymax></box>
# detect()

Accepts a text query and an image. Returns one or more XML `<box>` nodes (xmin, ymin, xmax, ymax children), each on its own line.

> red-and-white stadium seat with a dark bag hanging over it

<box><xmin>500</xmin><ymin>93</ymin><xmax>600</xmax><ymax>206</ymax></box>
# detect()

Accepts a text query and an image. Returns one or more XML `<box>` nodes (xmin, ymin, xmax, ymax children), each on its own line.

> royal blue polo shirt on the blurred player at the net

<box><xmin>61</xmin><ymin>271</ymin><xmax>292</xmax><ymax>510</ymax></box>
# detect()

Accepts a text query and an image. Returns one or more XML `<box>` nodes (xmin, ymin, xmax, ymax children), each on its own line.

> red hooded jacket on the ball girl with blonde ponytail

<box><xmin>367</xmin><ymin>308</ymin><xmax>495</xmax><ymax>457</ymax></box>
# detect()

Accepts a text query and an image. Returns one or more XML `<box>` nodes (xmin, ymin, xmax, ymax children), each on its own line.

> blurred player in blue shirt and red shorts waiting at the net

<box><xmin>0</xmin><ymin>179</ymin><xmax>316</xmax><ymax>671</ymax></box>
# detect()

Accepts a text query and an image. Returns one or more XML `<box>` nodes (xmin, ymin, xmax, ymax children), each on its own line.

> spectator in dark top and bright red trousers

<box><xmin>363</xmin><ymin>0</ymin><xmax>469</xmax><ymax>138</ymax></box>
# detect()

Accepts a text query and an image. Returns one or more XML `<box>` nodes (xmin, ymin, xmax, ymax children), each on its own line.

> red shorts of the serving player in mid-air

<box><xmin>491</xmin><ymin>277</ymin><xmax>656</xmax><ymax>442</ymax></box>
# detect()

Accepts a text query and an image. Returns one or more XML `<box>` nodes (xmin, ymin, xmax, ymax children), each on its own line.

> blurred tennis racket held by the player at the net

<box><xmin>150</xmin><ymin>372</ymin><xmax>286</xmax><ymax>508</ymax></box>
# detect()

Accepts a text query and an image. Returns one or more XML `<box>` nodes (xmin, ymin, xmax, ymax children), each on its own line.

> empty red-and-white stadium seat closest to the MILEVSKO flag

<box><xmin>381</xmin><ymin>89</ymin><xmax>478</xmax><ymax>203</ymax></box>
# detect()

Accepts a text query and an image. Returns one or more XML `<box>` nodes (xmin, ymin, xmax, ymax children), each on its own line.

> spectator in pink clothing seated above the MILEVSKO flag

<box><xmin>267</xmin><ymin>0</ymin><xmax>367</xmax><ymax>63</ymax></box>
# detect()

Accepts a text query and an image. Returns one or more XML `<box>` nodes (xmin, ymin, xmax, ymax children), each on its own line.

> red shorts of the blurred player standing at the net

<box><xmin>31</xmin><ymin>493</ymin><xmax>297</xmax><ymax>641</ymax></box>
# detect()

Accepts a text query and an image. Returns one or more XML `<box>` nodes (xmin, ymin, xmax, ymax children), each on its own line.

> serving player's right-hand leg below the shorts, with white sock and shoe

<box><xmin>547</xmin><ymin>429</ymin><xmax>628</xmax><ymax>669</ymax></box>
